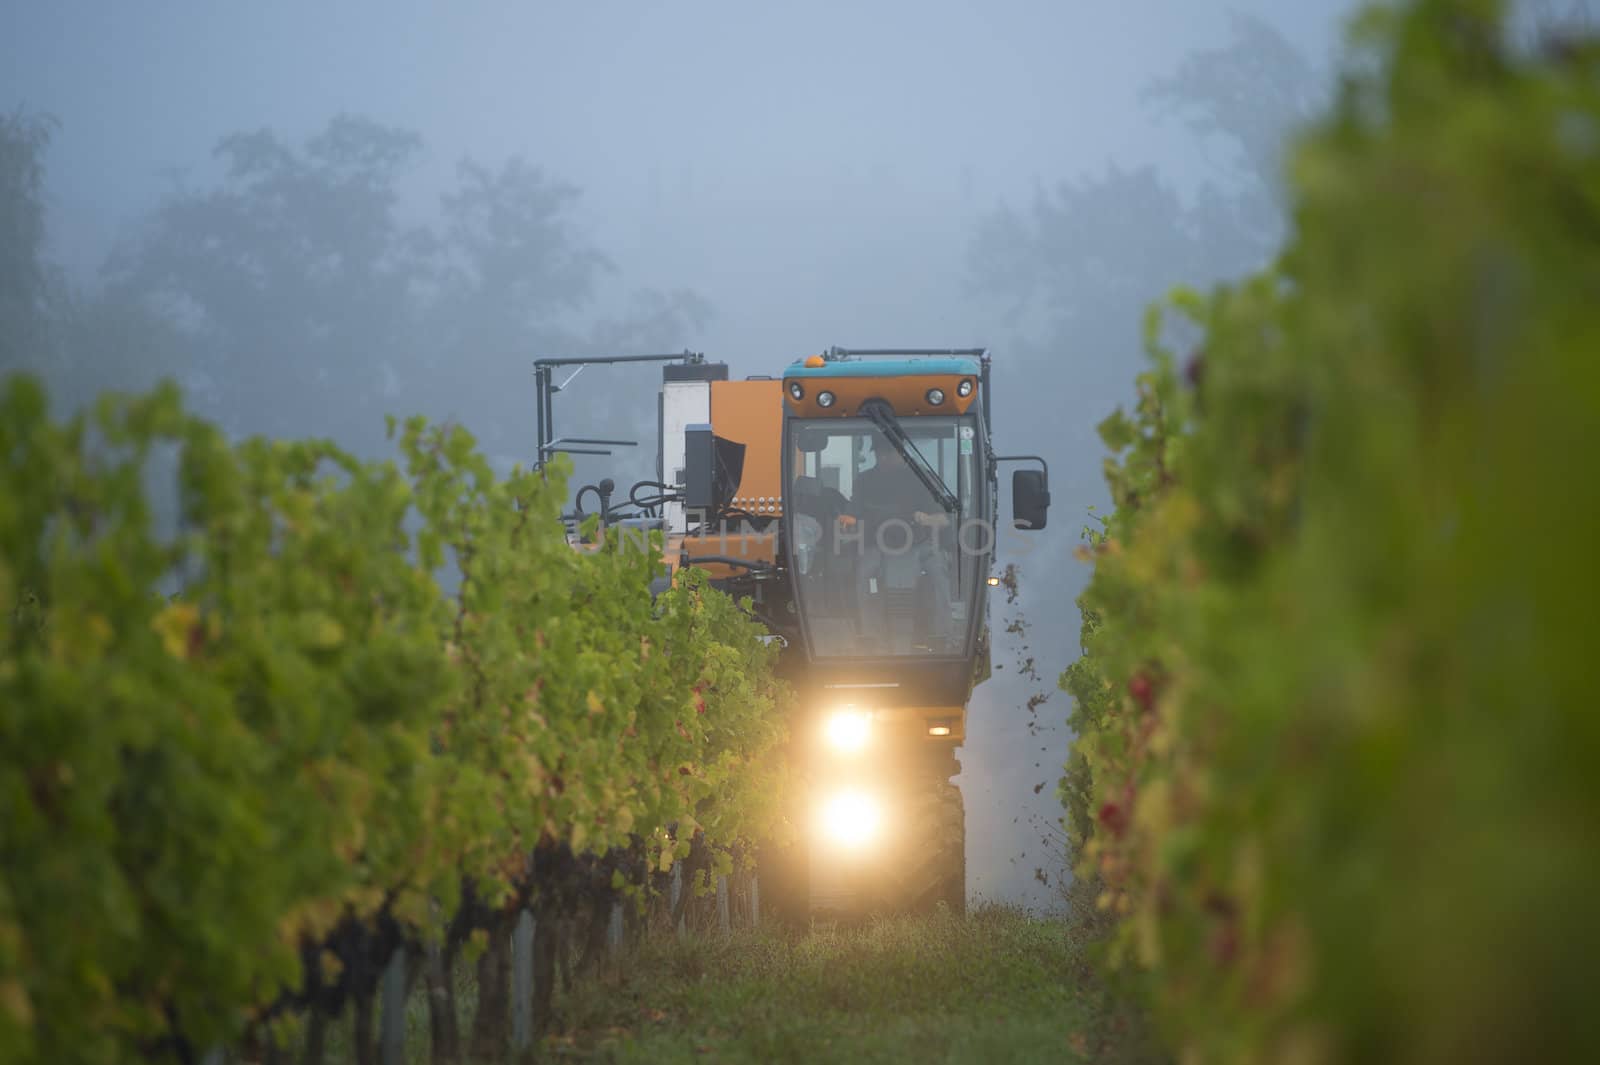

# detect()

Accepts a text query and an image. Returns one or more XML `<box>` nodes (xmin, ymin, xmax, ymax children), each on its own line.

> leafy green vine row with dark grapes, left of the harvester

<box><xmin>0</xmin><ymin>377</ymin><xmax>786</xmax><ymax>1065</ymax></box>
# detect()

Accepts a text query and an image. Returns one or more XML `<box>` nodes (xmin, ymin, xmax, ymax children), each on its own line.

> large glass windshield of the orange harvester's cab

<box><xmin>786</xmin><ymin>416</ymin><xmax>992</xmax><ymax>657</ymax></box>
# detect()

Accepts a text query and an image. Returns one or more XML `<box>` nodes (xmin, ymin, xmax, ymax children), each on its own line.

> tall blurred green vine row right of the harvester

<box><xmin>1062</xmin><ymin>0</ymin><xmax>1600</xmax><ymax>1062</ymax></box>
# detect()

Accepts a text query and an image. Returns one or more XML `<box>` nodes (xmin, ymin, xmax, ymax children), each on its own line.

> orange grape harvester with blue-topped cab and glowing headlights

<box><xmin>534</xmin><ymin>347</ymin><xmax>1050</xmax><ymax>916</ymax></box>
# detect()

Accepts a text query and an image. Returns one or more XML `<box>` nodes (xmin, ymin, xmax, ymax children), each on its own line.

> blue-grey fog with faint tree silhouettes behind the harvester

<box><xmin>0</xmin><ymin>0</ymin><xmax>1349</xmax><ymax>907</ymax></box>
